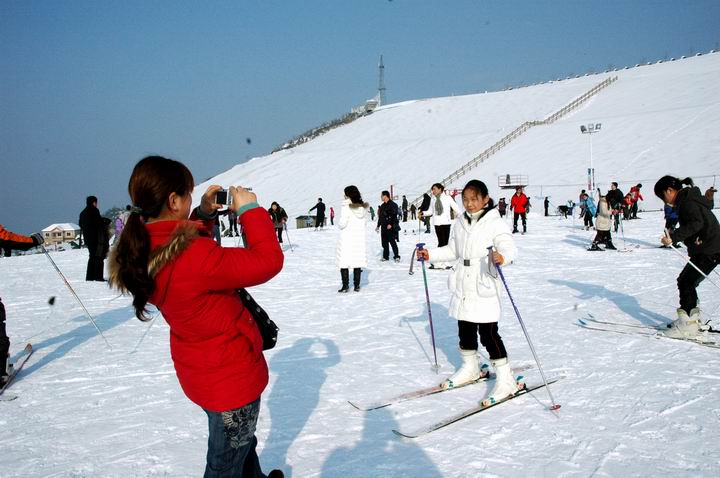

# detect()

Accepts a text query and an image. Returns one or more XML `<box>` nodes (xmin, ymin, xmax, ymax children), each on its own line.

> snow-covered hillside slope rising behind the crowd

<box><xmin>196</xmin><ymin>53</ymin><xmax>720</xmax><ymax>216</ymax></box>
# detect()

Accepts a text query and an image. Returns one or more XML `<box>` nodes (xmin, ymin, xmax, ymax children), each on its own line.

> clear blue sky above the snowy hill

<box><xmin>0</xmin><ymin>0</ymin><xmax>720</xmax><ymax>233</ymax></box>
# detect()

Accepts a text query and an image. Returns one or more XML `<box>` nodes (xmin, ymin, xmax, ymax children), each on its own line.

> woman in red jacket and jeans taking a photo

<box><xmin>110</xmin><ymin>156</ymin><xmax>283</xmax><ymax>477</ymax></box>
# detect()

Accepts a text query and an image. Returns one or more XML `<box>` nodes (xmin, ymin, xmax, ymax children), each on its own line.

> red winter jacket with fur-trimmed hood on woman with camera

<box><xmin>147</xmin><ymin>207</ymin><xmax>283</xmax><ymax>412</ymax></box>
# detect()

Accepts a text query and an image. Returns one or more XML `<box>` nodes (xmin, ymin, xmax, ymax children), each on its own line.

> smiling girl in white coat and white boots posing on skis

<box><xmin>417</xmin><ymin>179</ymin><xmax>523</xmax><ymax>405</ymax></box>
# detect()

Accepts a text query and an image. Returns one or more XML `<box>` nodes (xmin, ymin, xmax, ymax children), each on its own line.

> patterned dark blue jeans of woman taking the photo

<box><xmin>204</xmin><ymin>398</ymin><xmax>265</xmax><ymax>478</ymax></box>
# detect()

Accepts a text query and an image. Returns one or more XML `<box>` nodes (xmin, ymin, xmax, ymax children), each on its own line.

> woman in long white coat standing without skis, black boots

<box><xmin>335</xmin><ymin>186</ymin><xmax>370</xmax><ymax>293</ymax></box>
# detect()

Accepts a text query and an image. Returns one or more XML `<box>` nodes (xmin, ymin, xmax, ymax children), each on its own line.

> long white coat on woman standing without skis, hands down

<box><xmin>335</xmin><ymin>199</ymin><xmax>368</xmax><ymax>269</ymax></box>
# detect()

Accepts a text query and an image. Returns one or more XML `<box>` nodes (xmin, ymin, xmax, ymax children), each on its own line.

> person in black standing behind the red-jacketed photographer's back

<box><xmin>78</xmin><ymin>196</ymin><xmax>110</xmax><ymax>281</ymax></box>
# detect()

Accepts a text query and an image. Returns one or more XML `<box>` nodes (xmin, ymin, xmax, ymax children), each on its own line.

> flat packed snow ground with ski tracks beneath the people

<box><xmin>0</xmin><ymin>210</ymin><xmax>720</xmax><ymax>478</ymax></box>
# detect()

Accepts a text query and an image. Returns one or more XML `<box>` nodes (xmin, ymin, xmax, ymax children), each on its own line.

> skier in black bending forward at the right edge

<box><xmin>655</xmin><ymin>176</ymin><xmax>720</xmax><ymax>338</ymax></box>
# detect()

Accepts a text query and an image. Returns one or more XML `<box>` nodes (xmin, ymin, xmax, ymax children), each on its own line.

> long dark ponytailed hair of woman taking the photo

<box><xmin>110</xmin><ymin>156</ymin><xmax>195</xmax><ymax>321</ymax></box>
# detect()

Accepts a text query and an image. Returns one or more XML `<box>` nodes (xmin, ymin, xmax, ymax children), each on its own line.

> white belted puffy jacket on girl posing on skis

<box><xmin>428</xmin><ymin>208</ymin><xmax>517</xmax><ymax>323</ymax></box>
